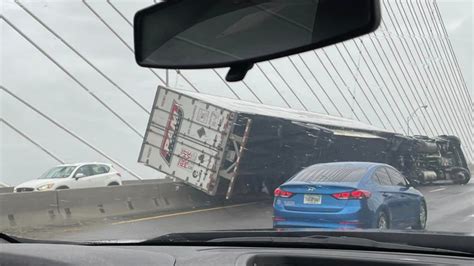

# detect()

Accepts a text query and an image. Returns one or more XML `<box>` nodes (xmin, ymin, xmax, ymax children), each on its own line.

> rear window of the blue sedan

<box><xmin>292</xmin><ymin>164</ymin><xmax>368</xmax><ymax>183</ymax></box>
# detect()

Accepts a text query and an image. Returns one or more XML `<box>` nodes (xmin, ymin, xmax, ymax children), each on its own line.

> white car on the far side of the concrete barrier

<box><xmin>14</xmin><ymin>163</ymin><xmax>122</xmax><ymax>192</ymax></box>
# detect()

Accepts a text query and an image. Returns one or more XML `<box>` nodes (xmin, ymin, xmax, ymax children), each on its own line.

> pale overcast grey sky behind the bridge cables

<box><xmin>0</xmin><ymin>0</ymin><xmax>474</xmax><ymax>185</ymax></box>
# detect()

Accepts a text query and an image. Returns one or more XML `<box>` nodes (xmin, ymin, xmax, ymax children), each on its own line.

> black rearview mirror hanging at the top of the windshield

<box><xmin>134</xmin><ymin>0</ymin><xmax>380</xmax><ymax>81</ymax></box>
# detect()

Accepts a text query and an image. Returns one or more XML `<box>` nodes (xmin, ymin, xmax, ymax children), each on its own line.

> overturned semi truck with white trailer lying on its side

<box><xmin>139</xmin><ymin>86</ymin><xmax>471</xmax><ymax>198</ymax></box>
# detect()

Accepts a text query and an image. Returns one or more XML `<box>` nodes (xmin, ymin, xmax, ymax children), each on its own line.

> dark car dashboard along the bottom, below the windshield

<box><xmin>0</xmin><ymin>243</ymin><xmax>474</xmax><ymax>266</ymax></box>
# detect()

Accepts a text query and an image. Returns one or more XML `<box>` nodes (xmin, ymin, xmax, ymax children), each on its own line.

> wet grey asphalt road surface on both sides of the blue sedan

<box><xmin>36</xmin><ymin>181</ymin><xmax>474</xmax><ymax>241</ymax></box>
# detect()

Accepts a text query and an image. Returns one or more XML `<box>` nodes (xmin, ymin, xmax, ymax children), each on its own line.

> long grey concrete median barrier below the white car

<box><xmin>0</xmin><ymin>180</ymin><xmax>217</xmax><ymax>231</ymax></box>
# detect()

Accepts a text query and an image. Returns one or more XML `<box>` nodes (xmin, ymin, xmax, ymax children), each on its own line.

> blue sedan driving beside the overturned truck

<box><xmin>273</xmin><ymin>162</ymin><xmax>427</xmax><ymax>229</ymax></box>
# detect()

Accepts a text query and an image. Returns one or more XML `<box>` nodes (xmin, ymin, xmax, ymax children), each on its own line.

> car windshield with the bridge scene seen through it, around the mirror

<box><xmin>0</xmin><ymin>0</ymin><xmax>474</xmax><ymax>247</ymax></box>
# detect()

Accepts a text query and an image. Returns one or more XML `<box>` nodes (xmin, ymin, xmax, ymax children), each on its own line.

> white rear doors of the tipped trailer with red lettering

<box><xmin>138</xmin><ymin>86</ymin><xmax>235</xmax><ymax>195</ymax></box>
